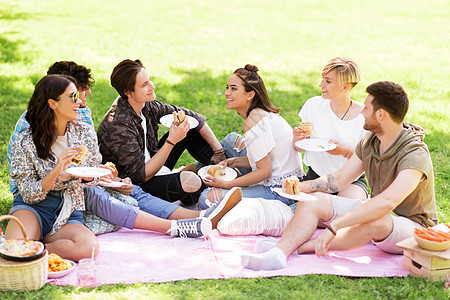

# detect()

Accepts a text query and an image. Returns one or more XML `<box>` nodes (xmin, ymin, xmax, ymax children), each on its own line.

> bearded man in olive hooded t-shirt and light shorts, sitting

<box><xmin>241</xmin><ymin>81</ymin><xmax>437</xmax><ymax>270</ymax></box>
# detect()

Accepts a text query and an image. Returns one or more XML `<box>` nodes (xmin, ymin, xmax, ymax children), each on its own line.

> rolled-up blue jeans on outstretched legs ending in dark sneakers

<box><xmin>84</xmin><ymin>185</ymin><xmax>179</xmax><ymax>229</ymax></box>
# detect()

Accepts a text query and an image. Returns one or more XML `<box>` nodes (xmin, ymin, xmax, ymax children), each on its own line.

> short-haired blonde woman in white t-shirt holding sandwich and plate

<box><xmin>293</xmin><ymin>57</ymin><xmax>367</xmax><ymax>199</ymax></box>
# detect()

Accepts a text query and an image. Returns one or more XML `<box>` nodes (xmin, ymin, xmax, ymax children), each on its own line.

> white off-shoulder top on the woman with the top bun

<box><xmin>244</xmin><ymin>113</ymin><xmax>304</xmax><ymax>186</ymax></box>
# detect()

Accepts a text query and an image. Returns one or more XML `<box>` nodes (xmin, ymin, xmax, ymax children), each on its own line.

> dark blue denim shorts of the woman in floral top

<box><xmin>9</xmin><ymin>190</ymin><xmax>83</xmax><ymax>240</ymax></box>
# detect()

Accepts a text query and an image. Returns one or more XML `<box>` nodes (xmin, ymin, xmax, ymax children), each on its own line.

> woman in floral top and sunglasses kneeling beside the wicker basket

<box><xmin>6</xmin><ymin>75</ymin><xmax>100</xmax><ymax>261</ymax></box>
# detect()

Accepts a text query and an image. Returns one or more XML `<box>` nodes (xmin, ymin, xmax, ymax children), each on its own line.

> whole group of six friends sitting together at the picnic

<box><xmin>6</xmin><ymin>57</ymin><xmax>438</xmax><ymax>270</ymax></box>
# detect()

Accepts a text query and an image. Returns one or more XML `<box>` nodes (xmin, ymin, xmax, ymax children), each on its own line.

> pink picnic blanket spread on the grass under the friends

<box><xmin>48</xmin><ymin>228</ymin><xmax>409</xmax><ymax>286</ymax></box>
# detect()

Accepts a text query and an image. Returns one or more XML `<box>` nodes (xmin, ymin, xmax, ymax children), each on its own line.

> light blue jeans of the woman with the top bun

<box><xmin>198</xmin><ymin>185</ymin><xmax>297</xmax><ymax>209</ymax></box>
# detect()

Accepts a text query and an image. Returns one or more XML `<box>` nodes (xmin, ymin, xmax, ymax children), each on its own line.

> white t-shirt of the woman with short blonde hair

<box><xmin>298</xmin><ymin>96</ymin><xmax>368</xmax><ymax>176</ymax></box>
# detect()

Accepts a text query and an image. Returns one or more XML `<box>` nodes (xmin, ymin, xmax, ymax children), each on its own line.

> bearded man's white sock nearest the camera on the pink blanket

<box><xmin>241</xmin><ymin>247</ymin><xmax>287</xmax><ymax>271</ymax></box>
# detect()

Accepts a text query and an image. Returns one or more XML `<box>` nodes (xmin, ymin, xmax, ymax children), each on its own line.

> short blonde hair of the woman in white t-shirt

<box><xmin>320</xmin><ymin>57</ymin><xmax>361</xmax><ymax>88</ymax></box>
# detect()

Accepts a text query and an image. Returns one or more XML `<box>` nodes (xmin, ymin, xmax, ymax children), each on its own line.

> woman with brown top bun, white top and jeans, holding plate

<box><xmin>199</xmin><ymin>64</ymin><xmax>304</xmax><ymax>209</ymax></box>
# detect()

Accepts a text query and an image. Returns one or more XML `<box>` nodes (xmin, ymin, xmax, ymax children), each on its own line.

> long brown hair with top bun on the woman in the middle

<box><xmin>233</xmin><ymin>64</ymin><xmax>280</xmax><ymax>117</ymax></box>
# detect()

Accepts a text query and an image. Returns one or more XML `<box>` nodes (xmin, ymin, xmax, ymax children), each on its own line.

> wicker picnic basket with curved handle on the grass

<box><xmin>0</xmin><ymin>216</ymin><xmax>48</xmax><ymax>291</ymax></box>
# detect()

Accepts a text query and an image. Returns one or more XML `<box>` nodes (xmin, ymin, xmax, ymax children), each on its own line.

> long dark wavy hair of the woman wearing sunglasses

<box><xmin>25</xmin><ymin>75</ymin><xmax>76</xmax><ymax>160</ymax></box>
